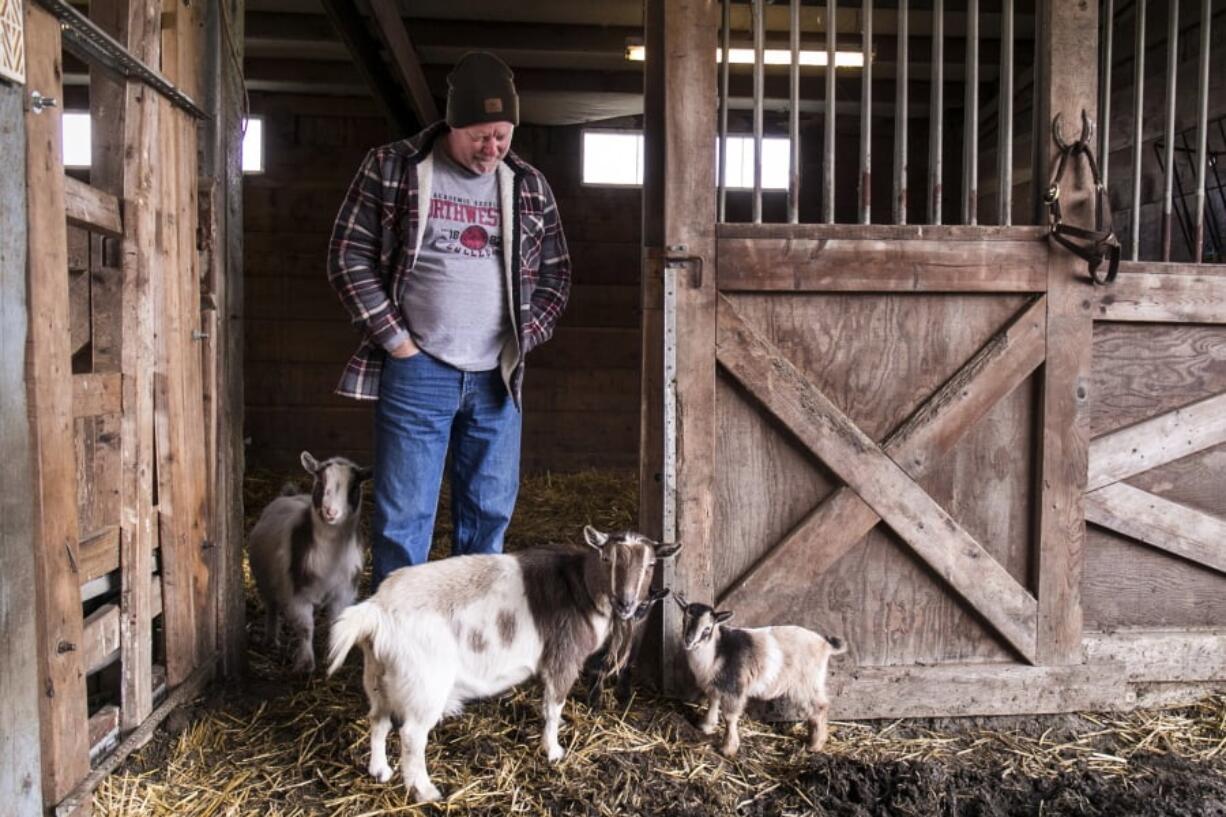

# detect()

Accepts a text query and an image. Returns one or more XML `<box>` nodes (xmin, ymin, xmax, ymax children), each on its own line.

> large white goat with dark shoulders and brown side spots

<box><xmin>329</xmin><ymin>526</ymin><xmax>680</xmax><ymax>802</ymax></box>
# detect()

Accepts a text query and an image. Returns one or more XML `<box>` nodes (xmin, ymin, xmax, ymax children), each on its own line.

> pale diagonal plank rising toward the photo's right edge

<box><xmin>1086</xmin><ymin>393</ymin><xmax>1226</xmax><ymax>491</ymax></box>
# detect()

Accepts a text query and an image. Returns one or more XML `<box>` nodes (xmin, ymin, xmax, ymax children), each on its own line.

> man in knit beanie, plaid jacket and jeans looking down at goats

<box><xmin>329</xmin><ymin>52</ymin><xmax>570</xmax><ymax>591</ymax></box>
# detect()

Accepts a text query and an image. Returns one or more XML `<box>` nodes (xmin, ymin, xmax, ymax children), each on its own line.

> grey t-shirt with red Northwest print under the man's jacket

<box><xmin>401</xmin><ymin>146</ymin><xmax>511</xmax><ymax>372</ymax></box>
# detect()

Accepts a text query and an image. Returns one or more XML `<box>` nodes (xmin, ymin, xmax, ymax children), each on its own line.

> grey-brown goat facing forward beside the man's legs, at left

<box><xmin>246</xmin><ymin>451</ymin><xmax>370</xmax><ymax>672</ymax></box>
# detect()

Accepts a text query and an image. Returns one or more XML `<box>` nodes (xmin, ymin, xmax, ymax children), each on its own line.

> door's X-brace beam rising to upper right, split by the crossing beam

<box><xmin>718</xmin><ymin>298</ymin><xmax>1047</xmax><ymax>613</ymax></box>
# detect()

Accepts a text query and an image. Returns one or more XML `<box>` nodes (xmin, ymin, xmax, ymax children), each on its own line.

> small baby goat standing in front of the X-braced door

<box><xmin>673</xmin><ymin>594</ymin><xmax>847</xmax><ymax>757</ymax></box>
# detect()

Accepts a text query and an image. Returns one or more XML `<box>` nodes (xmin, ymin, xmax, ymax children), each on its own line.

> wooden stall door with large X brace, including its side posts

<box><xmin>642</xmin><ymin>0</ymin><xmax>1176</xmax><ymax>718</ymax></box>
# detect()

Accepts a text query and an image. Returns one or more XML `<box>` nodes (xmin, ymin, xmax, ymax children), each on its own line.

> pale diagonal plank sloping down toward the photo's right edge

<box><xmin>1085</xmin><ymin>482</ymin><xmax>1226</xmax><ymax>573</ymax></box>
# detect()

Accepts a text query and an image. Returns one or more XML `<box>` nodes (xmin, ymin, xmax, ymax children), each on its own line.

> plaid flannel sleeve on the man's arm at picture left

<box><xmin>327</xmin><ymin>151</ymin><xmax>408</xmax><ymax>351</ymax></box>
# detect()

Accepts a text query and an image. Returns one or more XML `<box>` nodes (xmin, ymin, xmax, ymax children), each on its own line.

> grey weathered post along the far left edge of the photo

<box><xmin>0</xmin><ymin>73</ymin><xmax>43</xmax><ymax>817</ymax></box>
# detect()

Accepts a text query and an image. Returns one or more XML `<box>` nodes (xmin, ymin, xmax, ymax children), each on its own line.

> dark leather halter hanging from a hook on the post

<box><xmin>1043</xmin><ymin>110</ymin><xmax>1119</xmax><ymax>285</ymax></box>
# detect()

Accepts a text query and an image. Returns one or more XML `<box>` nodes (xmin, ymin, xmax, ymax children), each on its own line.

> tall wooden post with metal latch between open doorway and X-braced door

<box><xmin>661</xmin><ymin>0</ymin><xmax>718</xmax><ymax>688</ymax></box>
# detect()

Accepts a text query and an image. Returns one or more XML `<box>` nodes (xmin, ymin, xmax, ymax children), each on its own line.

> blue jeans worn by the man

<box><xmin>370</xmin><ymin>352</ymin><xmax>521</xmax><ymax>593</ymax></box>
